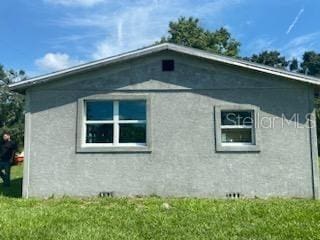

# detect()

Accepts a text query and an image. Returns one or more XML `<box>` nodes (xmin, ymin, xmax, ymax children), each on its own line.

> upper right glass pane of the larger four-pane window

<box><xmin>119</xmin><ymin>101</ymin><xmax>146</xmax><ymax>120</ymax></box>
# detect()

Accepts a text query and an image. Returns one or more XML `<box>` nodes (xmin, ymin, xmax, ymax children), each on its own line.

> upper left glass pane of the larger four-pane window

<box><xmin>87</xmin><ymin>101</ymin><xmax>113</xmax><ymax>121</ymax></box>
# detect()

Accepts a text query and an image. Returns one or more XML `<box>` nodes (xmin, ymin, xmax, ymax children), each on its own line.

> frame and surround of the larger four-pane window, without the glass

<box><xmin>77</xmin><ymin>95</ymin><xmax>151</xmax><ymax>152</ymax></box>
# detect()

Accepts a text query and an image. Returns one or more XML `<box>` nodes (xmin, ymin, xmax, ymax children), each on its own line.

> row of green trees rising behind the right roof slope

<box><xmin>160</xmin><ymin>17</ymin><xmax>320</xmax><ymax>76</ymax></box>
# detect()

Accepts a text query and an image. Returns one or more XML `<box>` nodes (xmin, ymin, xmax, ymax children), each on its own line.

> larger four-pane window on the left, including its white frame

<box><xmin>77</xmin><ymin>97</ymin><xmax>149</xmax><ymax>152</ymax></box>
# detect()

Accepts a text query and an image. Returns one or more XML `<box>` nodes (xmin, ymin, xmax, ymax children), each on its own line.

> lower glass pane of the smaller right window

<box><xmin>221</xmin><ymin>128</ymin><xmax>252</xmax><ymax>143</ymax></box>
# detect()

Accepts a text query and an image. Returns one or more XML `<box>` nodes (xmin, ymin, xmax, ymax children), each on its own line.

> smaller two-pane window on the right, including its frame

<box><xmin>215</xmin><ymin>105</ymin><xmax>259</xmax><ymax>151</ymax></box>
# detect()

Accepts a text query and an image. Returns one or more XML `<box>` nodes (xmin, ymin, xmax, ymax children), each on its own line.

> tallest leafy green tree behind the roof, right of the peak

<box><xmin>160</xmin><ymin>17</ymin><xmax>240</xmax><ymax>57</ymax></box>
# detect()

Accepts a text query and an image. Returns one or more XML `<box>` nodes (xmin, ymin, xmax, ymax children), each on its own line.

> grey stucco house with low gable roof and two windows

<box><xmin>10</xmin><ymin>43</ymin><xmax>320</xmax><ymax>198</ymax></box>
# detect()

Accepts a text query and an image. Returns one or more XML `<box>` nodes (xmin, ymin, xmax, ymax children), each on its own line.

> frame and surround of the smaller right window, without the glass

<box><xmin>214</xmin><ymin>104</ymin><xmax>260</xmax><ymax>152</ymax></box>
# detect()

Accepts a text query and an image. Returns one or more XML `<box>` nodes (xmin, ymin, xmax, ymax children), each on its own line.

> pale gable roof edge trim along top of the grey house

<box><xmin>9</xmin><ymin>43</ymin><xmax>320</xmax><ymax>92</ymax></box>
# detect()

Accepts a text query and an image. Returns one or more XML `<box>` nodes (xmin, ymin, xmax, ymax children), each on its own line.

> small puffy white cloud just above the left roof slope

<box><xmin>35</xmin><ymin>53</ymin><xmax>83</xmax><ymax>72</ymax></box>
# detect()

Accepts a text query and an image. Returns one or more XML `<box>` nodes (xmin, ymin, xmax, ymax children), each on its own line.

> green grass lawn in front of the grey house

<box><xmin>0</xmin><ymin>167</ymin><xmax>320</xmax><ymax>240</ymax></box>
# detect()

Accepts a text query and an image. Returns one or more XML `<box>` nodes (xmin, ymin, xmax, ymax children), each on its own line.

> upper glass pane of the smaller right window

<box><xmin>221</xmin><ymin>111</ymin><xmax>253</xmax><ymax>126</ymax></box>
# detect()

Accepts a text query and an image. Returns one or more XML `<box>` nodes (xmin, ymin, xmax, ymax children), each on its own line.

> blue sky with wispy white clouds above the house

<box><xmin>0</xmin><ymin>0</ymin><xmax>320</xmax><ymax>76</ymax></box>
